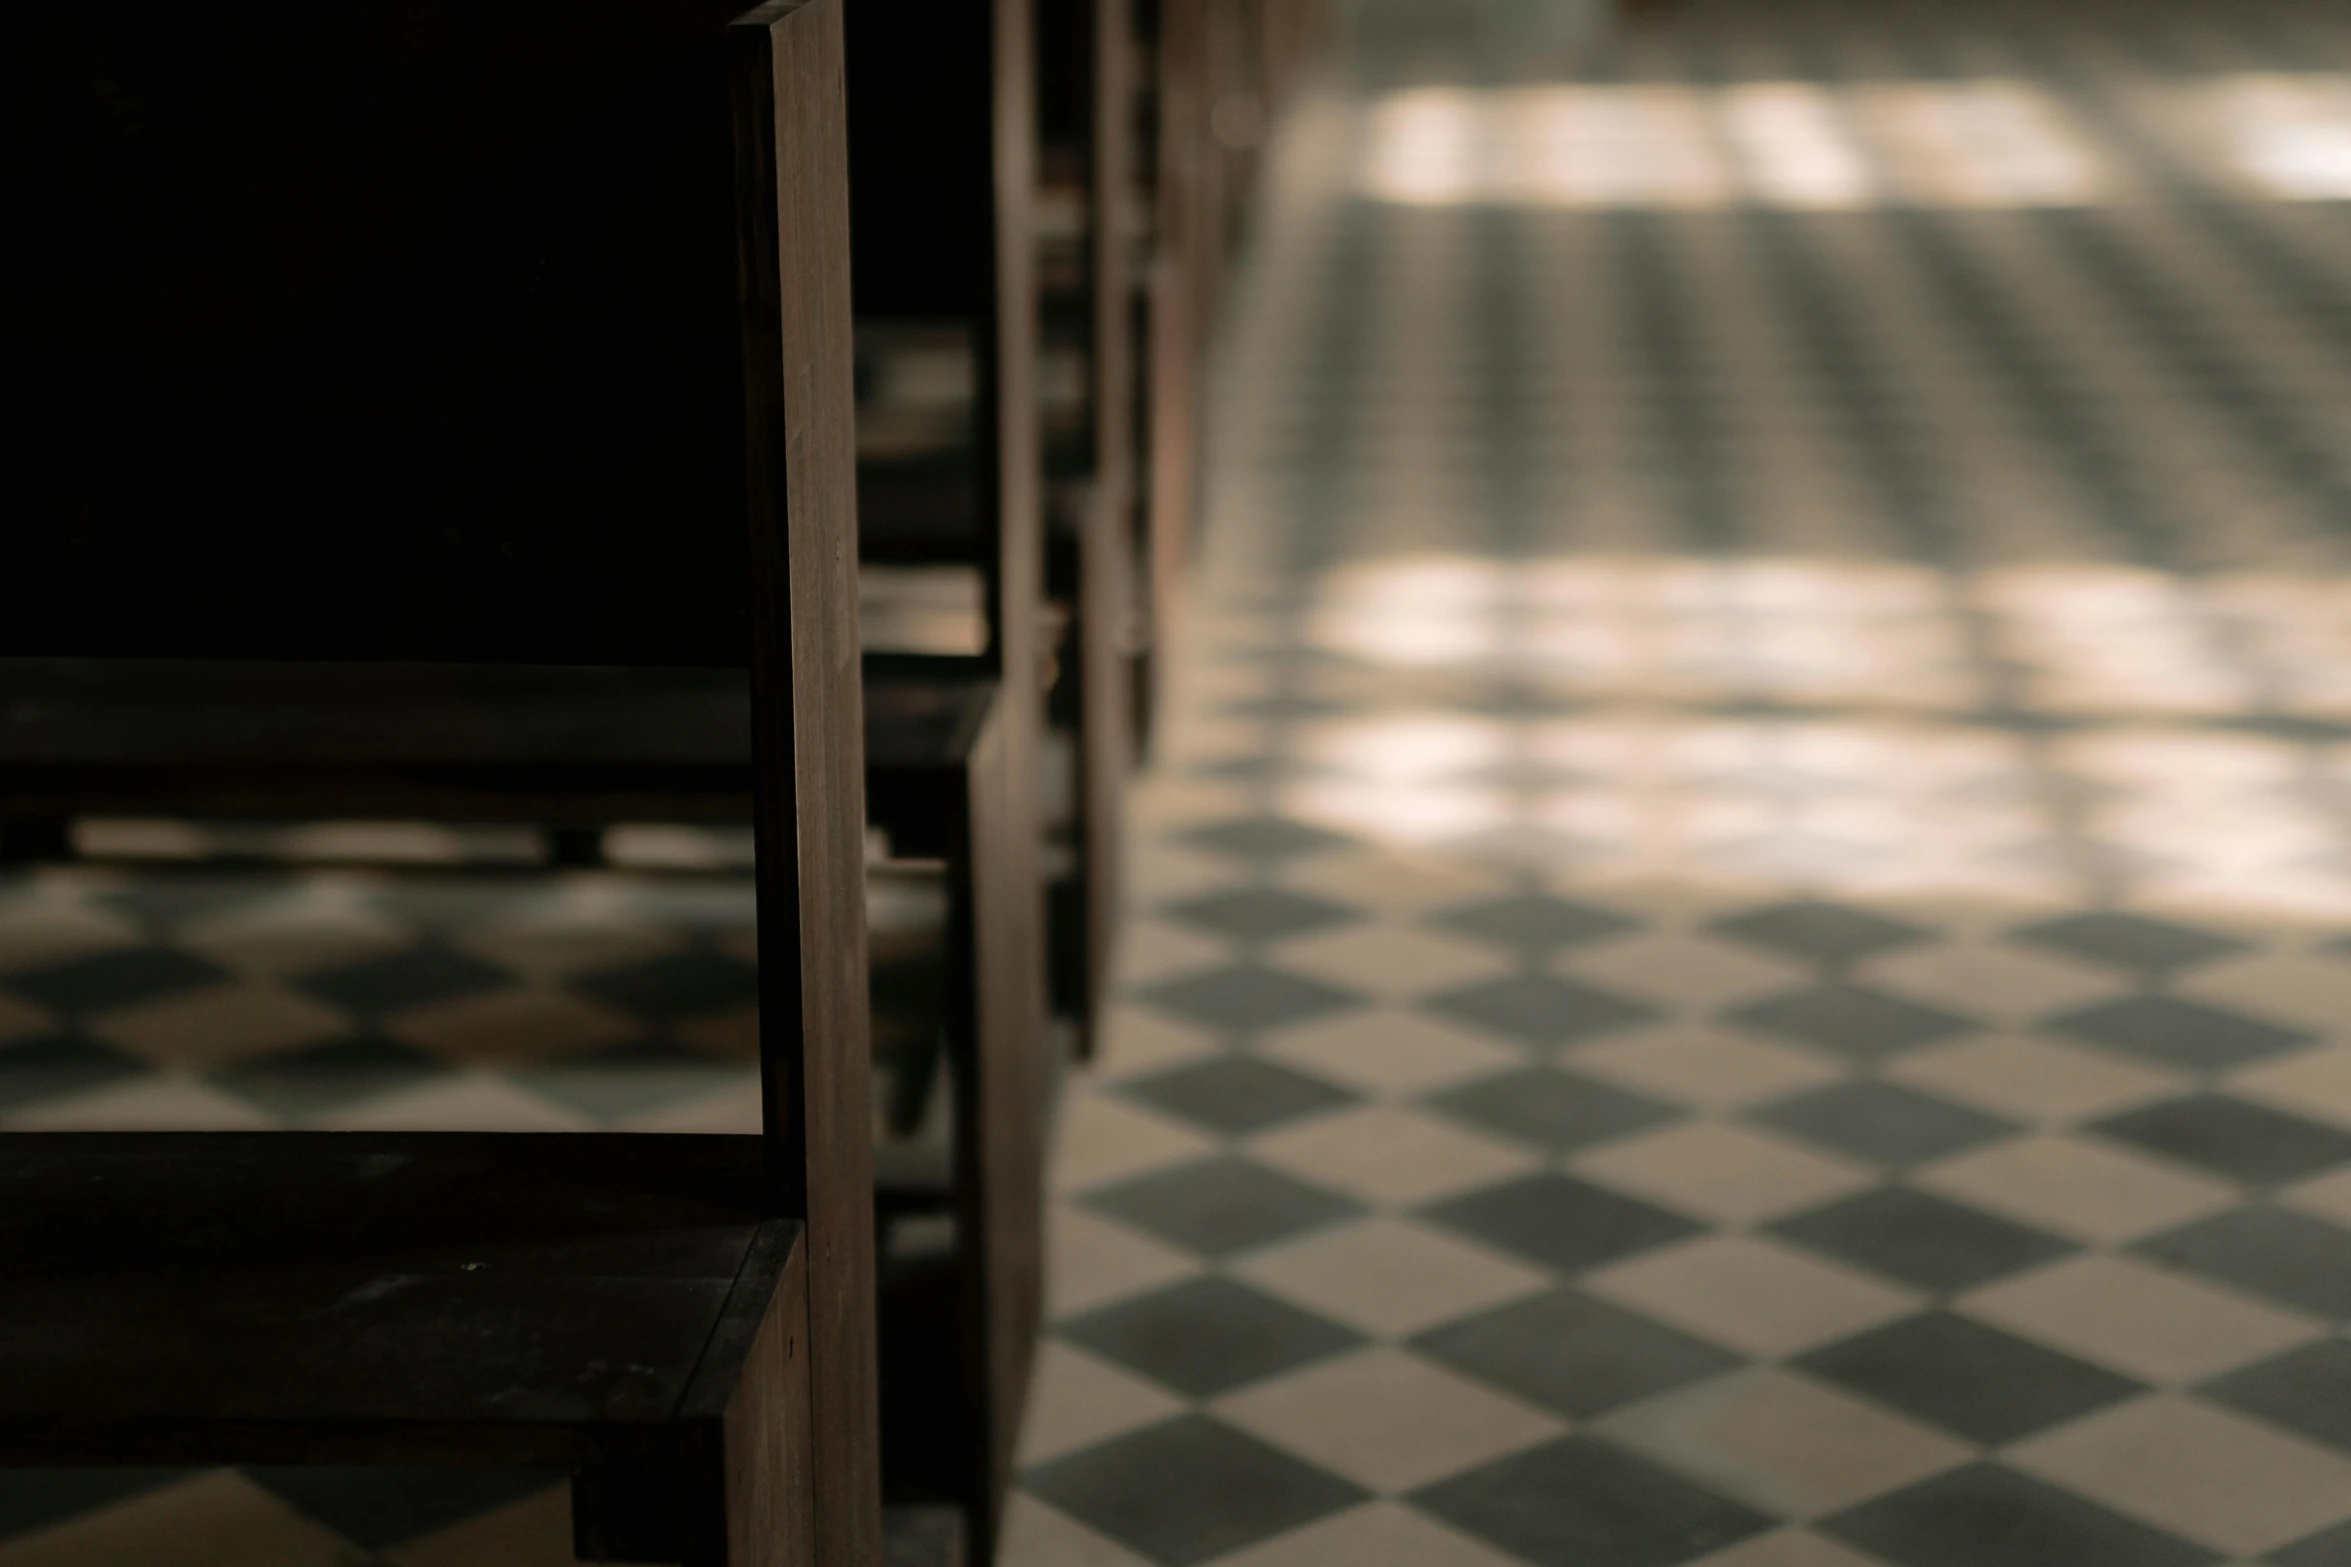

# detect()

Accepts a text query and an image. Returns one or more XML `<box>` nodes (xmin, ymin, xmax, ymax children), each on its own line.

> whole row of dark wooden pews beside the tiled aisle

<box><xmin>0</xmin><ymin>0</ymin><xmax>1314</xmax><ymax>1567</ymax></box>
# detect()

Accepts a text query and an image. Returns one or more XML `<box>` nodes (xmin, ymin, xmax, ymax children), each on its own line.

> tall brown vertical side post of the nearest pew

<box><xmin>729</xmin><ymin>0</ymin><xmax>882</xmax><ymax>1567</ymax></box>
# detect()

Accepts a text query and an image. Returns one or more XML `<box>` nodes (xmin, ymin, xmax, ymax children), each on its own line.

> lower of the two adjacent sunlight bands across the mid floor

<box><xmin>1274</xmin><ymin>712</ymin><xmax>2351</xmax><ymax>916</ymax></box>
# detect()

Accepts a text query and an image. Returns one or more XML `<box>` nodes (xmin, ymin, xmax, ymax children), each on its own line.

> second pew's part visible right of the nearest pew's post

<box><xmin>849</xmin><ymin>0</ymin><xmax>1060</xmax><ymax>1562</ymax></box>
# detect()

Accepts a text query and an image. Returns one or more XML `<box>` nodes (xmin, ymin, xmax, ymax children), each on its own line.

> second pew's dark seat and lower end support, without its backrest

<box><xmin>0</xmin><ymin>655</ymin><xmax>1051</xmax><ymax>1560</ymax></box>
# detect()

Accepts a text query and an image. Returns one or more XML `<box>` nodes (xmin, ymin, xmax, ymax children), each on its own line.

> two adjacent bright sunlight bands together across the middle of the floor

<box><xmin>1279</xmin><ymin>557</ymin><xmax>2351</xmax><ymax>919</ymax></box>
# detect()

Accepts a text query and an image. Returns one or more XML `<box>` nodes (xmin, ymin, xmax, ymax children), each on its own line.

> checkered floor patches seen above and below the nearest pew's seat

<box><xmin>0</xmin><ymin>865</ymin><xmax>907</xmax><ymax>1567</ymax></box>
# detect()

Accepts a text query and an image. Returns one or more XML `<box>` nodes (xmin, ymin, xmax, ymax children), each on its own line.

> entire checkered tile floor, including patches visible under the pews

<box><xmin>22</xmin><ymin>0</ymin><xmax>2351</xmax><ymax>1567</ymax></box>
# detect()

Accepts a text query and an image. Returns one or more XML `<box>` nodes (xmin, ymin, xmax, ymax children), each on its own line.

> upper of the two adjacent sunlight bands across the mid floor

<box><xmin>1307</xmin><ymin>557</ymin><xmax>2351</xmax><ymax>719</ymax></box>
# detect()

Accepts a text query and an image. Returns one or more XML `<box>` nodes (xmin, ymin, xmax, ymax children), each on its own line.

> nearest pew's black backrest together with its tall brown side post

<box><xmin>0</xmin><ymin>0</ymin><xmax>879</xmax><ymax>1562</ymax></box>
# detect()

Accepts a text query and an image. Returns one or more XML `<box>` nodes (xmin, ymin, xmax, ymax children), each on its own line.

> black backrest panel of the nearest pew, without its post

<box><xmin>0</xmin><ymin>0</ymin><xmax>813</xmax><ymax>665</ymax></box>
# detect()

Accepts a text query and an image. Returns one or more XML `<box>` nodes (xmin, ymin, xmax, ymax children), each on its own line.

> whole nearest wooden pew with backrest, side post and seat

<box><xmin>0</xmin><ymin>0</ymin><xmax>882</xmax><ymax>1567</ymax></box>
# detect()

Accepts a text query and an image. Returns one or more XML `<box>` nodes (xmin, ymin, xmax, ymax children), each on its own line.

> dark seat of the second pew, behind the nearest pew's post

<box><xmin>0</xmin><ymin>653</ymin><xmax>997</xmax><ymax>853</ymax></box>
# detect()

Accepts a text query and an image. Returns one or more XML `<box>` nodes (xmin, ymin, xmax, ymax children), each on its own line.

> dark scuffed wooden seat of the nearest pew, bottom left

<box><xmin>0</xmin><ymin>1132</ymin><xmax>799</xmax><ymax>1466</ymax></box>
